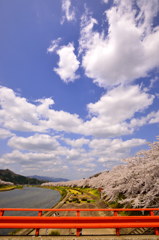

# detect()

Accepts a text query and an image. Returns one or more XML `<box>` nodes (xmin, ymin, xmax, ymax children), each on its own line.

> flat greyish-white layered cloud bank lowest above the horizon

<box><xmin>0</xmin><ymin>134</ymin><xmax>145</xmax><ymax>178</ymax></box>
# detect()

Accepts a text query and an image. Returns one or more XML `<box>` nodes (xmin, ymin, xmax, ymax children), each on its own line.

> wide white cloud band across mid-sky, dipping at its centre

<box><xmin>0</xmin><ymin>86</ymin><xmax>158</xmax><ymax>138</ymax></box>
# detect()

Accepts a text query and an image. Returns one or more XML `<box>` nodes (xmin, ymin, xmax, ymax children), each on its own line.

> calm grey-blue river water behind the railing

<box><xmin>0</xmin><ymin>187</ymin><xmax>61</xmax><ymax>235</ymax></box>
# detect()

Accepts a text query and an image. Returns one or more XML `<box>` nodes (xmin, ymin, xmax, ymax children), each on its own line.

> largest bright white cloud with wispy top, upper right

<box><xmin>79</xmin><ymin>0</ymin><xmax>159</xmax><ymax>87</ymax></box>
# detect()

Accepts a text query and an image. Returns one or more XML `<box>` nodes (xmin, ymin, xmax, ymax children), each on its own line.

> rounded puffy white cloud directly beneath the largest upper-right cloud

<box><xmin>87</xmin><ymin>85</ymin><xmax>154</xmax><ymax>123</ymax></box>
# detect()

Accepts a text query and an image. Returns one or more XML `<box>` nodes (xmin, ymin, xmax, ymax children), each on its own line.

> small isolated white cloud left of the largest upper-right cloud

<box><xmin>54</xmin><ymin>43</ymin><xmax>80</xmax><ymax>83</ymax></box>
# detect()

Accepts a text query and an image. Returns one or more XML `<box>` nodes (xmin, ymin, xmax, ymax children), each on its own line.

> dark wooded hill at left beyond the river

<box><xmin>0</xmin><ymin>169</ymin><xmax>44</xmax><ymax>185</ymax></box>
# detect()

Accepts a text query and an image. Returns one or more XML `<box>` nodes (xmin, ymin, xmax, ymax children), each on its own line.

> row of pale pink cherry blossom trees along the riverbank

<box><xmin>43</xmin><ymin>139</ymin><xmax>159</xmax><ymax>208</ymax></box>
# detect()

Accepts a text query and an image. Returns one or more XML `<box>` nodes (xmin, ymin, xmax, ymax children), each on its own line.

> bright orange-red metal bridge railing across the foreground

<box><xmin>0</xmin><ymin>208</ymin><xmax>159</xmax><ymax>236</ymax></box>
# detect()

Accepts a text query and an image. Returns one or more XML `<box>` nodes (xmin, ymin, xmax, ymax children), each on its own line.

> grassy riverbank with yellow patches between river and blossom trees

<box><xmin>16</xmin><ymin>187</ymin><xmax>110</xmax><ymax>237</ymax></box>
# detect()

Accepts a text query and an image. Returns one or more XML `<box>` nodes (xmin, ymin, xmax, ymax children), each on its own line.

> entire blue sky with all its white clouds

<box><xmin>0</xmin><ymin>0</ymin><xmax>159</xmax><ymax>179</ymax></box>
